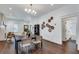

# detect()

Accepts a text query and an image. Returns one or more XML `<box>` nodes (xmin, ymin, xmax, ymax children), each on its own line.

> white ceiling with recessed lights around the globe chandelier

<box><xmin>0</xmin><ymin>4</ymin><xmax>64</xmax><ymax>19</ymax></box>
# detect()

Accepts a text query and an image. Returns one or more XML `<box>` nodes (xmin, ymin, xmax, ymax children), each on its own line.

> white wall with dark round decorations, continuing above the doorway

<box><xmin>32</xmin><ymin>5</ymin><xmax>79</xmax><ymax>44</ymax></box>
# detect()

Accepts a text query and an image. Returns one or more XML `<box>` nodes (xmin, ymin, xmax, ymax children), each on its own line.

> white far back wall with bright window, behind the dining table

<box><xmin>5</xmin><ymin>17</ymin><xmax>35</xmax><ymax>34</ymax></box>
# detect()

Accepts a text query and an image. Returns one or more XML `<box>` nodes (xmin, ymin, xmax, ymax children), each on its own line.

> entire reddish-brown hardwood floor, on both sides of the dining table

<box><xmin>0</xmin><ymin>40</ymin><xmax>79</xmax><ymax>54</ymax></box>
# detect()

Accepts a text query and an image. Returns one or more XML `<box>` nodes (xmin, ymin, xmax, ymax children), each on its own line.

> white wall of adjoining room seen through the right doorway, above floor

<box><xmin>62</xmin><ymin>17</ymin><xmax>77</xmax><ymax>41</ymax></box>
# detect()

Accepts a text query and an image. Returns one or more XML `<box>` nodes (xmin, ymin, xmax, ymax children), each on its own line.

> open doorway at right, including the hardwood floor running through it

<box><xmin>62</xmin><ymin>16</ymin><xmax>77</xmax><ymax>53</ymax></box>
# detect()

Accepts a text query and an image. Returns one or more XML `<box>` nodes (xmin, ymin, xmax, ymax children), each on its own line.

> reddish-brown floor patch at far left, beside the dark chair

<box><xmin>0</xmin><ymin>42</ymin><xmax>15</xmax><ymax>54</ymax></box>
